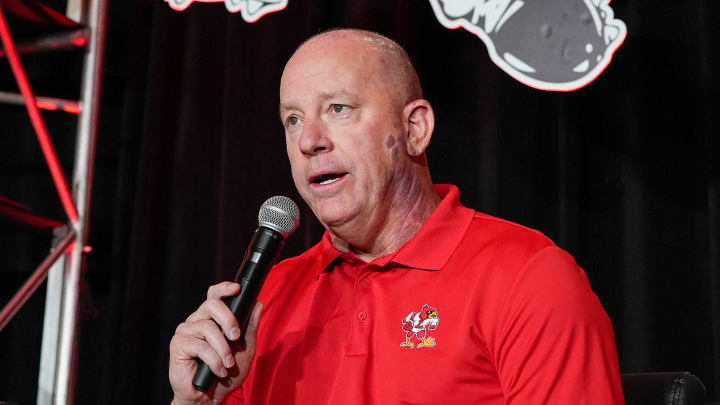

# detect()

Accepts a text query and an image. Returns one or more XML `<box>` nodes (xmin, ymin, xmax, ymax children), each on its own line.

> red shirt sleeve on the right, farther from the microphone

<box><xmin>488</xmin><ymin>246</ymin><xmax>625</xmax><ymax>405</ymax></box>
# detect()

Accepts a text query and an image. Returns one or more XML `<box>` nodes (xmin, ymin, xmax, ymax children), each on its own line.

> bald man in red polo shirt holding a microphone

<box><xmin>170</xmin><ymin>30</ymin><xmax>623</xmax><ymax>404</ymax></box>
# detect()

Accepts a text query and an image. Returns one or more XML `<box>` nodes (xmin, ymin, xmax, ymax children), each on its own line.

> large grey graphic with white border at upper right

<box><xmin>430</xmin><ymin>0</ymin><xmax>627</xmax><ymax>91</ymax></box>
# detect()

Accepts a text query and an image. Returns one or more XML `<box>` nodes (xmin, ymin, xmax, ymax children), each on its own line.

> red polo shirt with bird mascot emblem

<box><xmin>226</xmin><ymin>185</ymin><xmax>624</xmax><ymax>405</ymax></box>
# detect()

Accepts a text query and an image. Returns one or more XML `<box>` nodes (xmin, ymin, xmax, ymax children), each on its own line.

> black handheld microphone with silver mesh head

<box><xmin>193</xmin><ymin>196</ymin><xmax>300</xmax><ymax>392</ymax></box>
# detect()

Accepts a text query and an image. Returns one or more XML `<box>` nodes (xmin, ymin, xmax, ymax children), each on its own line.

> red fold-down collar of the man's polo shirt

<box><xmin>315</xmin><ymin>184</ymin><xmax>475</xmax><ymax>277</ymax></box>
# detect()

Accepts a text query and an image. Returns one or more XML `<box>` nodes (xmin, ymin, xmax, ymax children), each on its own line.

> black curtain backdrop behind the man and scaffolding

<box><xmin>0</xmin><ymin>0</ymin><xmax>720</xmax><ymax>404</ymax></box>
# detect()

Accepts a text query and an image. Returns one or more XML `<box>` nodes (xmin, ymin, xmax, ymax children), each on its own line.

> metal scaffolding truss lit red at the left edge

<box><xmin>0</xmin><ymin>0</ymin><xmax>107</xmax><ymax>405</ymax></box>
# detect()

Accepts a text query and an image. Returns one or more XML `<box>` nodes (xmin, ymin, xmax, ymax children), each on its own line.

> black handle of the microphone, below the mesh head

<box><xmin>193</xmin><ymin>226</ymin><xmax>285</xmax><ymax>392</ymax></box>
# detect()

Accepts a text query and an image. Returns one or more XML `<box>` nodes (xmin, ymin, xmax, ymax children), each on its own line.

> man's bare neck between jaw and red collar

<box><xmin>329</xmin><ymin>170</ymin><xmax>441</xmax><ymax>263</ymax></box>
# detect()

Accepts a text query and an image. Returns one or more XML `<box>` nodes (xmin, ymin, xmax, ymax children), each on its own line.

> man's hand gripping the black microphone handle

<box><xmin>169</xmin><ymin>282</ymin><xmax>262</xmax><ymax>404</ymax></box>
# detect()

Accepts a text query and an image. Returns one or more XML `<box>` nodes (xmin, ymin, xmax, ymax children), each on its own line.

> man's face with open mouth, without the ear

<box><xmin>280</xmin><ymin>38</ymin><xmax>404</xmax><ymax>232</ymax></box>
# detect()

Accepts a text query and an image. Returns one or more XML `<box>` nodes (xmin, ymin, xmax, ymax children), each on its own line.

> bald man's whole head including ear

<box><xmin>280</xmin><ymin>30</ymin><xmax>434</xmax><ymax>249</ymax></box>
